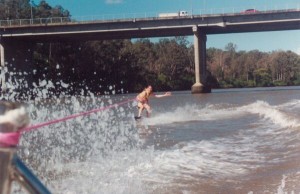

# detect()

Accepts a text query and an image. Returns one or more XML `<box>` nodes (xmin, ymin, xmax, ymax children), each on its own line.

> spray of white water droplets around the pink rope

<box><xmin>1</xmin><ymin>74</ymin><xmax>139</xmax><ymax>193</ymax></box>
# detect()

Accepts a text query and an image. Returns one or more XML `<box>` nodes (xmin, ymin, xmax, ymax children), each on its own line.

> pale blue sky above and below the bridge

<box><xmin>44</xmin><ymin>0</ymin><xmax>300</xmax><ymax>55</ymax></box>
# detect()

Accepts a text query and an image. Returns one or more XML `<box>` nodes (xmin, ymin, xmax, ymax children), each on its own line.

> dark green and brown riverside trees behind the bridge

<box><xmin>0</xmin><ymin>0</ymin><xmax>300</xmax><ymax>94</ymax></box>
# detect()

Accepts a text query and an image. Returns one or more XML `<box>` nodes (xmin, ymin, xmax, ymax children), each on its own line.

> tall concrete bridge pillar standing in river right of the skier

<box><xmin>192</xmin><ymin>26</ymin><xmax>211</xmax><ymax>94</ymax></box>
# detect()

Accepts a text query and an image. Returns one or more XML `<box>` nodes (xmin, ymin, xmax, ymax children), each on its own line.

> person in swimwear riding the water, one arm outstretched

<box><xmin>135</xmin><ymin>85</ymin><xmax>172</xmax><ymax>119</ymax></box>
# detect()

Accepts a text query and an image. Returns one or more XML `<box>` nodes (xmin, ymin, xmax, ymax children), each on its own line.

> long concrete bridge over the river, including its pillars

<box><xmin>0</xmin><ymin>9</ymin><xmax>300</xmax><ymax>93</ymax></box>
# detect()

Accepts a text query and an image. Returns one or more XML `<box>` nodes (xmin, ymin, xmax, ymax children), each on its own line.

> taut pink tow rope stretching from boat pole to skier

<box><xmin>0</xmin><ymin>98</ymin><xmax>135</xmax><ymax>146</ymax></box>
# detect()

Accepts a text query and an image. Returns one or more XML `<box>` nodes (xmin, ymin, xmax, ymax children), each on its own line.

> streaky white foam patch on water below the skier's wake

<box><xmin>125</xmin><ymin>139</ymin><xmax>265</xmax><ymax>184</ymax></box>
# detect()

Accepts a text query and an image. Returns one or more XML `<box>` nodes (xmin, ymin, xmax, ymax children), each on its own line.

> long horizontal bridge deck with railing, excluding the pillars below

<box><xmin>0</xmin><ymin>9</ymin><xmax>300</xmax><ymax>41</ymax></box>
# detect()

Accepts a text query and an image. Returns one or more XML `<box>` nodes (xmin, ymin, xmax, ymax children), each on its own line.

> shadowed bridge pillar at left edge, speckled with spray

<box><xmin>0</xmin><ymin>39</ymin><xmax>34</xmax><ymax>97</ymax></box>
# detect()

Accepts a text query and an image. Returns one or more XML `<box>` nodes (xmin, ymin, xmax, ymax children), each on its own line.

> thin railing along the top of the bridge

<box><xmin>0</xmin><ymin>3</ymin><xmax>300</xmax><ymax>27</ymax></box>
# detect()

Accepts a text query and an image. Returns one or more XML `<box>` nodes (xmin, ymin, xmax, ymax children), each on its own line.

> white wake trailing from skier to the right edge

<box><xmin>143</xmin><ymin>100</ymin><xmax>300</xmax><ymax>128</ymax></box>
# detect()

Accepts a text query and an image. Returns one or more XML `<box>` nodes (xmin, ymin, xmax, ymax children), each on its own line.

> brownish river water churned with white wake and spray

<box><xmin>12</xmin><ymin>87</ymin><xmax>300</xmax><ymax>194</ymax></box>
